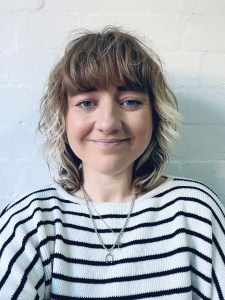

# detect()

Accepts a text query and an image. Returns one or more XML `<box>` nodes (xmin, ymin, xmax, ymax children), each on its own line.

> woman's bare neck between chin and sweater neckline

<box><xmin>80</xmin><ymin>168</ymin><xmax>134</xmax><ymax>202</ymax></box>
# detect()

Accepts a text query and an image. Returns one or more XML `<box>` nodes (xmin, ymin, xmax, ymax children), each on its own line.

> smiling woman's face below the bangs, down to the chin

<box><xmin>66</xmin><ymin>86</ymin><xmax>153</xmax><ymax>176</ymax></box>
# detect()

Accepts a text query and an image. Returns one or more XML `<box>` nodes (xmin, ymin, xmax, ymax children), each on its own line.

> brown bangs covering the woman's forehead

<box><xmin>62</xmin><ymin>31</ymin><xmax>151</xmax><ymax>95</ymax></box>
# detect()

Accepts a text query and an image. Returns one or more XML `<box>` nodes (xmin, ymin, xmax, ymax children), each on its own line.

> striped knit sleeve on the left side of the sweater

<box><xmin>0</xmin><ymin>199</ymin><xmax>46</xmax><ymax>300</ymax></box>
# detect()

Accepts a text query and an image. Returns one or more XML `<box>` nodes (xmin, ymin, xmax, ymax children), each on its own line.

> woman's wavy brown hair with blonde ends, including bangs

<box><xmin>38</xmin><ymin>27</ymin><xmax>180</xmax><ymax>193</ymax></box>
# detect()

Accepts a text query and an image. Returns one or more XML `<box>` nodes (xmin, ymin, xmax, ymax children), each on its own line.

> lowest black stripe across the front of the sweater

<box><xmin>51</xmin><ymin>286</ymin><xmax>192</xmax><ymax>300</ymax></box>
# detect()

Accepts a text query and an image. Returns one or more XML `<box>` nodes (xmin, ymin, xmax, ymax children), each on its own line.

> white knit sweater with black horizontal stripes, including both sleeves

<box><xmin>0</xmin><ymin>177</ymin><xmax>225</xmax><ymax>300</ymax></box>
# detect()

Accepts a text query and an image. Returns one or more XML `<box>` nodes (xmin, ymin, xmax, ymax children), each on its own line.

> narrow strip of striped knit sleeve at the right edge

<box><xmin>211</xmin><ymin>193</ymin><xmax>225</xmax><ymax>300</ymax></box>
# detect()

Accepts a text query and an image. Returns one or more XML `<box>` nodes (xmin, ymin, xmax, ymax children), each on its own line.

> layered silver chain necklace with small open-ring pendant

<box><xmin>81</xmin><ymin>186</ymin><xmax>136</xmax><ymax>263</ymax></box>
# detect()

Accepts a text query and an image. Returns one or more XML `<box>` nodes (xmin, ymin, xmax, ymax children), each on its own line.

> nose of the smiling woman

<box><xmin>95</xmin><ymin>99</ymin><xmax>122</xmax><ymax>134</ymax></box>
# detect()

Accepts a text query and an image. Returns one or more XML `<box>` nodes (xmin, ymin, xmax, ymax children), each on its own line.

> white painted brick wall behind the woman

<box><xmin>0</xmin><ymin>0</ymin><xmax>225</xmax><ymax>210</ymax></box>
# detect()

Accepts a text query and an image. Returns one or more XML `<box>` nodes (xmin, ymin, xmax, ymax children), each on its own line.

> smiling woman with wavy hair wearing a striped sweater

<box><xmin>0</xmin><ymin>28</ymin><xmax>225</xmax><ymax>300</ymax></box>
